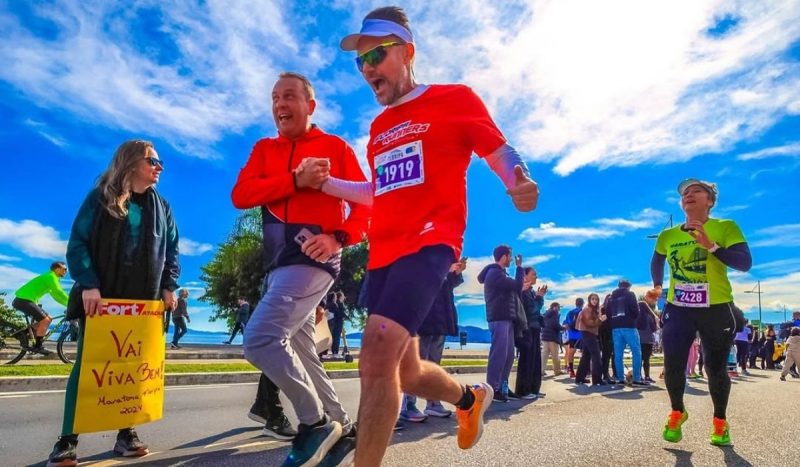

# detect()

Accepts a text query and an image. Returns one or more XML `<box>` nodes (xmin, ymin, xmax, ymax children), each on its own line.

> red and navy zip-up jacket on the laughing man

<box><xmin>231</xmin><ymin>126</ymin><xmax>369</xmax><ymax>276</ymax></box>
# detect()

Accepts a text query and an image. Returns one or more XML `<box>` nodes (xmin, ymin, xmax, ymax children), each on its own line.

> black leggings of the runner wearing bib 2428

<box><xmin>661</xmin><ymin>303</ymin><xmax>736</xmax><ymax>419</ymax></box>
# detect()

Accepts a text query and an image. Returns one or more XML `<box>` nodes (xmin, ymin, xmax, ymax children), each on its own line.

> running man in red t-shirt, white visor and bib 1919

<box><xmin>322</xmin><ymin>7</ymin><xmax>539</xmax><ymax>466</ymax></box>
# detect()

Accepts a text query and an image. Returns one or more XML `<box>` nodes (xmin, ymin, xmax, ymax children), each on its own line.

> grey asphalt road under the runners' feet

<box><xmin>0</xmin><ymin>370</ymin><xmax>800</xmax><ymax>467</ymax></box>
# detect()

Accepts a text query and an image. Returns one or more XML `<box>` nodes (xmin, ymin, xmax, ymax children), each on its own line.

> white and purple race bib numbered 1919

<box><xmin>375</xmin><ymin>141</ymin><xmax>425</xmax><ymax>196</ymax></box>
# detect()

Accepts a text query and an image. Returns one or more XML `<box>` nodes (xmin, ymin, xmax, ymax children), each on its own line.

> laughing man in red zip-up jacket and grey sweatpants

<box><xmin>231</xmin><ymin>73</ymin><xmax>369</xmax><ymax>465</ymax></box>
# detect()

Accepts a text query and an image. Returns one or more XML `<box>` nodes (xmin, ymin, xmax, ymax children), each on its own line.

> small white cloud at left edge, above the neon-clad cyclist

<box><xmin>0</xmin><ymin>219</ymin><xmax>67</xmax><ymax>260</ymax></box>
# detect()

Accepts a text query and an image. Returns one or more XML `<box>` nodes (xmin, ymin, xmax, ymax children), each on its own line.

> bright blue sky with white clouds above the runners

<box><xmin>0</xmin><ymin>0</ymin><xmax>800</xmax><ymax>330</ymax></box>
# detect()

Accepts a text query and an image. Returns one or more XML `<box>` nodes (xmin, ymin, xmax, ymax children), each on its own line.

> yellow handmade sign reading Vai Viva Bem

<box><xmin>72</xmin><ymin>298</ymin><xmax>165</xmax><ymax>433</ymax></box>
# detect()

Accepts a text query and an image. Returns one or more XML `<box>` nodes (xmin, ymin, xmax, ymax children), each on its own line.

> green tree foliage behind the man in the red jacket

<box><xmin>200</xmin><ymin>209</ymin><xmax>368</xmax><ymax>329</ymax></box>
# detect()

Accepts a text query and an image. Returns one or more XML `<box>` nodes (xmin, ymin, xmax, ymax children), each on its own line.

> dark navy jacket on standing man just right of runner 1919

<box><xmin>478</xmin><ymin>263</ymin><xmax>524</xmax><ymax>323</ymax></box>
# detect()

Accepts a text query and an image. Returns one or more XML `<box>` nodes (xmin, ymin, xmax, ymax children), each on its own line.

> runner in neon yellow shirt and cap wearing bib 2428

<box><xmin>650</xmin><ymin>178</ymin><xmax>752</xmax><ymax>446</ymax></box>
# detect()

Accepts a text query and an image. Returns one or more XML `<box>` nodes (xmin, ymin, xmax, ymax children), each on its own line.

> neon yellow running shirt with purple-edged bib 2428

<box><xmin>656</xmin><ymin>219</ymin><xmax>745</xmax><ymax>308</ymax></box>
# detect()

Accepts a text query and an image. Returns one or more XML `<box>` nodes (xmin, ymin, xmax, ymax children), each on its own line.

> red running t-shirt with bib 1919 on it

<box><xmin>367</xmin><ymin>84</ymin><xmax>506</xmax><ymax>269</ymax></box>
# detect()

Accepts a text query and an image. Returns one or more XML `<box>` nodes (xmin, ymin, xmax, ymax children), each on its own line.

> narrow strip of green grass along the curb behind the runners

<box><xmin>0</xmin><ymin>359</ymin><xmax>487</xmax><ymax>377</ymax></box>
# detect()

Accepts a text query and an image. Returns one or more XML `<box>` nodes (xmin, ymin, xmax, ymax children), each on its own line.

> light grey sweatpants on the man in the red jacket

<box><xmin>244</xmin><ymin>265</ymin><xmax>347</xmax><ymax>425</ymax></box>
